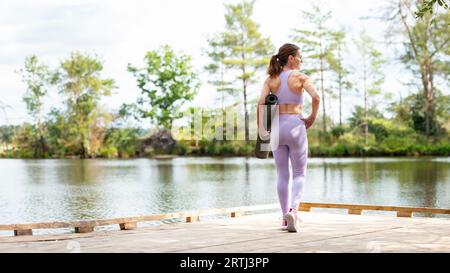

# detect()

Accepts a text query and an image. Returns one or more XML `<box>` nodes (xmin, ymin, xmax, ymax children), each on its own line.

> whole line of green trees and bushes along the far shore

<box><xmin>0</xmin><ymin>0</ymin><xmax>450</xmax><ymax>158</ymax></box>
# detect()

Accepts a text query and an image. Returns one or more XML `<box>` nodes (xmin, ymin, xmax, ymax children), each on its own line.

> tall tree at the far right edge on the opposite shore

<box><xmin>386</xmin><ymin>0</ymin><xmax>450</xmax><ymax>137</ymax></box>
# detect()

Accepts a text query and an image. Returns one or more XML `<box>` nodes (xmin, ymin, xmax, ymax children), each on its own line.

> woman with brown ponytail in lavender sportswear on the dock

<box><xmin>257</xmin><ymin>43</ymin><xmax>320</xmax><ymax>232</ymax></box>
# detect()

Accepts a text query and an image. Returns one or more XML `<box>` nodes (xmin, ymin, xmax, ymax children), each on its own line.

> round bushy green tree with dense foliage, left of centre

<box><xmin>122</xmin><ymin>45</ymin><xmax>200</xmax><ymax>129</ymax></box>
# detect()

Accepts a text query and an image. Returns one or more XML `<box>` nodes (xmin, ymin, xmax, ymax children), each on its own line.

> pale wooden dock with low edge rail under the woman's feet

<box><xmin>0</xmin><ymin>203</ymin><xmax>450</xmax><ymax>253</ymax></box>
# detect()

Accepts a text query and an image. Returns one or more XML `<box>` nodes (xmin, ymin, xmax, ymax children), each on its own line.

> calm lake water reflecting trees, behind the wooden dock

<box><xmin>0</xmin><ymin>157</ymin><xmax>450</xmax><ymax>228</ymax></box>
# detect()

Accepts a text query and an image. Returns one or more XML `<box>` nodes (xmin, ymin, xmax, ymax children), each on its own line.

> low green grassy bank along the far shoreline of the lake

<box><xmin>0</xmin><ymin>139</ymin><xmax>450</xmax><ymax>158</ymax></box>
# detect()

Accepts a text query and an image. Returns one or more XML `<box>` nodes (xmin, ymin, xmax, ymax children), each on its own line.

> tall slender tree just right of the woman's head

<box><xmin>292</xmin><ymin>4</ymin><xmax>337</xmax><ymax>132</ymax></box>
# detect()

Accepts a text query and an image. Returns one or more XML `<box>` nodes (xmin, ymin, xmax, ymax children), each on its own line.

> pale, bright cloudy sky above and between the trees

<box><xmin>0</xmin><ymin>0</ymin><xmax>422</xmax><ymax>125</ymax></box>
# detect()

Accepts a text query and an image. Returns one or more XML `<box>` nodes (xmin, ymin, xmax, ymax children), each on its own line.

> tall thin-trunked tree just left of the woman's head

<box><xmin>211</xmin><ymin>0</ymin><xmax>273</xmax><ymax>142</ymax></box>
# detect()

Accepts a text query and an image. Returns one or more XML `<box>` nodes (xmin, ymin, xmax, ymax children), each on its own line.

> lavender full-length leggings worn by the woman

<box><xmin>271</xmin><ymin>114</ymin><xmax>308</xmax><ymax>215</ymax></box>
